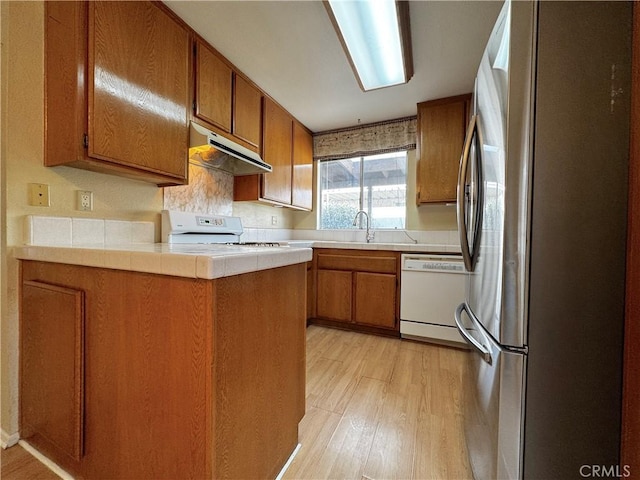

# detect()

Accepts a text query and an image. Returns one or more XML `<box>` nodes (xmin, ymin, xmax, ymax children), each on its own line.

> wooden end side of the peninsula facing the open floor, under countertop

<box><xmin>213</xmin><ymin>264</ymin><xmax>306</xmax><ymax>479</ymax></box>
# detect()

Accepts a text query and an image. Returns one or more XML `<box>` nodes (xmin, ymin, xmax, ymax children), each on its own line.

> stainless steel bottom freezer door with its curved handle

<box><xmin>455</xmin><ymin>304</ymin><xmax>526</xmax><ymax>480</ymax></box>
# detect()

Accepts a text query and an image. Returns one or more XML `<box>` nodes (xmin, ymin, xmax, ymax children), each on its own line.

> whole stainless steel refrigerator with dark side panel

<box><xmin>455</xmin><ymin>1</ymin><xmax>632</xmax><ymax>480</ymax></box>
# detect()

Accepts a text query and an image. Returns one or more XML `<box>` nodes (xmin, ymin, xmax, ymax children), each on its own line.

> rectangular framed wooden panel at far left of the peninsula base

<box><xmin>20</xmin><ymin>280</ymin><xmax>84</xmax><ymax>462</ymax></box>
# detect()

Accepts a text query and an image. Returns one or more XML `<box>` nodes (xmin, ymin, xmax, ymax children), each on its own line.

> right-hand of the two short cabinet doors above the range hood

<box><xmin>233</xmin><ymin>74</ymin><xmax>262</xmax><ymax>152</ymax></box>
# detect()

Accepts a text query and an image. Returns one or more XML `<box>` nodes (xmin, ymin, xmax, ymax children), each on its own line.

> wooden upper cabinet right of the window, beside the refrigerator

<box><xmin>416</xmin><ymin>94</ymin><xmax>471</xmax><ymax>205</ymax></box>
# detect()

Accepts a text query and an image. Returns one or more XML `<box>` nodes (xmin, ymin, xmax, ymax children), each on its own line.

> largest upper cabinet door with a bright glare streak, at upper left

<box><xmin>88</xmin><ymin>2</ymin><xmax>191</xmax><ymax>179</ymax></box>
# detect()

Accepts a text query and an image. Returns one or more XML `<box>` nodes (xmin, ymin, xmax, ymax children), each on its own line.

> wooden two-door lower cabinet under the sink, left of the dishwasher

<box><xmin>309</xmin><ymin>249</ymin><xmax>400</xmax><ymax>336</ymax></box>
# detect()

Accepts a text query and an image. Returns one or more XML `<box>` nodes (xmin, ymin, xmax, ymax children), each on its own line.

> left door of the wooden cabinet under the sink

<box><xmin>316</xmin><ymin>270</ymin><xmax>353</xmax><ymax>322</ymax></box>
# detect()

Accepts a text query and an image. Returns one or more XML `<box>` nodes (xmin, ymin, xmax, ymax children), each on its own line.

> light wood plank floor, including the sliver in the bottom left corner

<box><xmin>1</xmin><ymin>326</ymin><xmax>471</xmax><ymax>480</ymax></box>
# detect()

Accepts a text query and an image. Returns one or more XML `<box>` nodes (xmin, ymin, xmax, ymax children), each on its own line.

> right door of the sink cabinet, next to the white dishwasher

<box><xmin>354</xmin><ymin>272</ymin><xmax>396</xmax><ymax>328</ymax></box>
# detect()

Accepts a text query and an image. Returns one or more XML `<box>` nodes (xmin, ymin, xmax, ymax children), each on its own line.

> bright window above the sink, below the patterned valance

<box><xmin>318</xmin><ymin>151</ymin><xmax>407</xmax><ymax>229</ymax></box>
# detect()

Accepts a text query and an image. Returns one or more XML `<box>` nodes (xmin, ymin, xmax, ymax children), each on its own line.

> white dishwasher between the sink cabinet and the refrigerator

<box><xmin>400</xmin><ymin>254</ymin><xmax>466</xmax><ymax>347</ymax></box>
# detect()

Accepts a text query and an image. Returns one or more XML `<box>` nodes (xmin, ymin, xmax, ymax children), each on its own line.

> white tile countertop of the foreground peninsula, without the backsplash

<box><xmin>14</xmin><ymin>243</ymin><xmax>312</xmax><ymax>279</ymax></box>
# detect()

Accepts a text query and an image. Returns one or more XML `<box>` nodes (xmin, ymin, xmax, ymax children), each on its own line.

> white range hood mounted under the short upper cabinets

<box><xmin>189</xmin><ymin>122</ymin><xmax>272</xmax><ymax>176</ymax></box>
